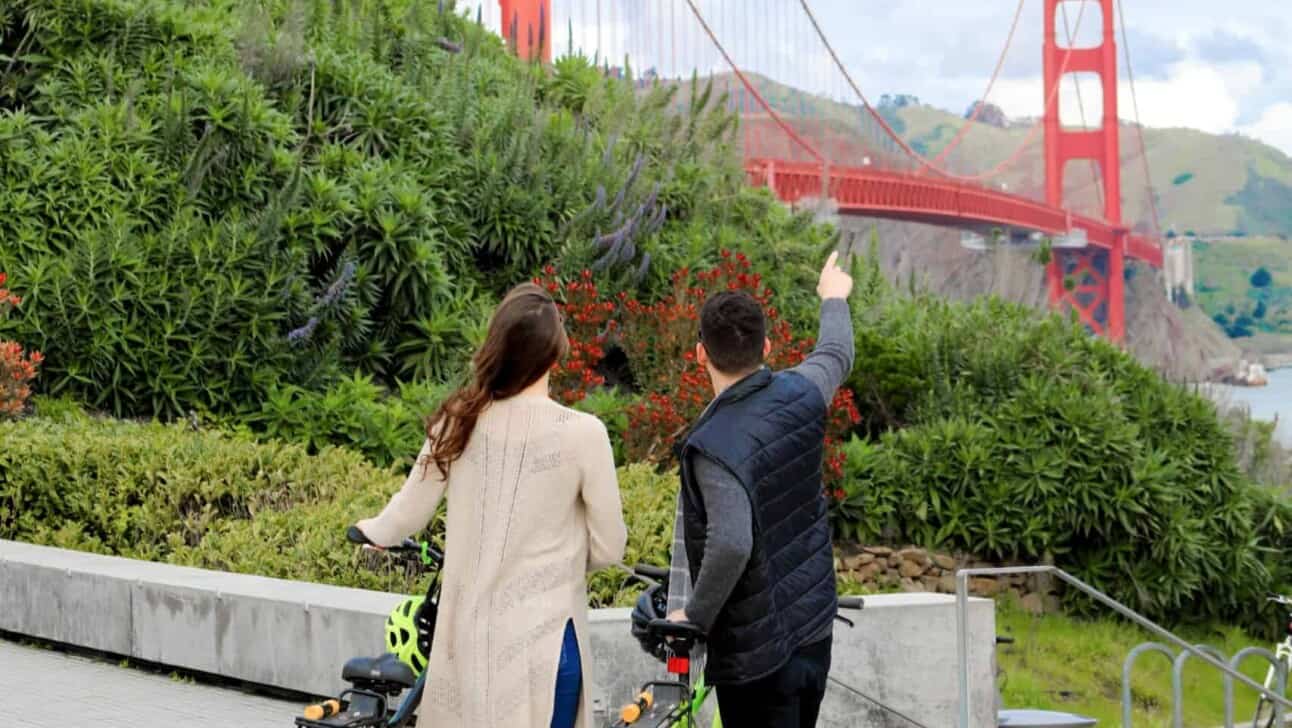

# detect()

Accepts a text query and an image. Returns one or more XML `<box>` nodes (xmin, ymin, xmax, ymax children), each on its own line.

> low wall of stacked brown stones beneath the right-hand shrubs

<box><xmin>836</xmin><ymin>546</ymin><xmax>1059</xmax><ymax>614</ymax></box>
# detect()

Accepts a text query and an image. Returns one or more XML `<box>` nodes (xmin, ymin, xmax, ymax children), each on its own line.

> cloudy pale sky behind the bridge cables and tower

<box><xmin>485</xmin><ymin>0</ymin><xmax>1292</xmax><ymax>154</ymax></box>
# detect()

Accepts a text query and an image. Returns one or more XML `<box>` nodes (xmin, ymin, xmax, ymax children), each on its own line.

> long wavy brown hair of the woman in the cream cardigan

<box><xmin>424</xmin><ymin>283</ymin><xmax>570</xmax><ymax>477</ymax></box>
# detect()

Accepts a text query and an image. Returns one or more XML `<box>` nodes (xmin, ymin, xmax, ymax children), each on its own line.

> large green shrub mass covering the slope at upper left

<box><xmin>0</xmin><ymin>0</ymin><xmax>824</xmax><ymax>421</ymax></box>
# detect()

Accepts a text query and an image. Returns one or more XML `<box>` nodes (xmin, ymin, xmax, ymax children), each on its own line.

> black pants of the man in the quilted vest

<box><xmin>717</xmin><ymin>637</ymin><xmax>833</xmax><ymax>728</ymax></box>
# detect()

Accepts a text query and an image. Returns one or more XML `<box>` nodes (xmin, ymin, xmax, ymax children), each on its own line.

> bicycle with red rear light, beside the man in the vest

<box><xmin>610</xmin><ymin>564</ymin><xmax>863</xmax><ymax>728</ymax></box>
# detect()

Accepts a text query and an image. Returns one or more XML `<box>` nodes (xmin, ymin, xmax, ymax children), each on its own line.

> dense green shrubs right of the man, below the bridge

<box><xmin>836</xmin><ymin>258</ymin><xmax>1287</xmax><ymax>619</ymax></box>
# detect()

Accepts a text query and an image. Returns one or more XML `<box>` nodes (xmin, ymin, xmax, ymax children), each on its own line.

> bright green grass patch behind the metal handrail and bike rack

<box><xmin>996</xmin><ymin>601</ymin><xmax>1273</xmax><ymax>728</ymax></box>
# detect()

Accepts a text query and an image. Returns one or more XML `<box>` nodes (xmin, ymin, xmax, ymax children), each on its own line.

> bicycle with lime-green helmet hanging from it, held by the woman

<box><xmin>296</xmin><ymin>526</ymin><xmax>444</xmax><ymax>728</ymax></box>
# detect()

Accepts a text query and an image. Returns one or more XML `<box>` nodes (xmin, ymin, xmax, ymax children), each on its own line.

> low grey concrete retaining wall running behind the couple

<box><xmin>0</xmin><ymin>541</ymin><xmax>995</xmax><ymax>728</ymax></box>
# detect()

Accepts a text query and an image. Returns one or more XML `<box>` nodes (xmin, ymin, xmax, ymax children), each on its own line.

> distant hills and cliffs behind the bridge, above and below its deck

<box><xmin>656</xmin><ymin>75</ymin><xmax>1292</xmax><ymax>369</ymax></box>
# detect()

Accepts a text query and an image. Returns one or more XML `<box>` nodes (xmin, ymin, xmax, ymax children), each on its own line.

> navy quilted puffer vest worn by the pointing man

<box><xmin>678</xmin><ymin>369</ymin><xmax>837</xmax><ymax>684</ymax></box>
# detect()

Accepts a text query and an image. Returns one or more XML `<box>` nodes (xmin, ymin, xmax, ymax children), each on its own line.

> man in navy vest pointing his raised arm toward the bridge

<box><xmin>669</xmin><ymin>253</ymin><xmax>853</xmax><ymax>728</ymax></box>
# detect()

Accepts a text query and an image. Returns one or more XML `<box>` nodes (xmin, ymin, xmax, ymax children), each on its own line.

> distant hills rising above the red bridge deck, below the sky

<box><xmin>682</xmin><ymin>75</ymin><xmax>1292</xmax><ymax>237</ymax></box>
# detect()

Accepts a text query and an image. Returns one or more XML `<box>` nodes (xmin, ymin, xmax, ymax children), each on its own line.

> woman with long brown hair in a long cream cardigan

<box><xmin>358</xmin><ymin>283</ymin><xmax>627</xmax><ymax>728</ymax></box>
